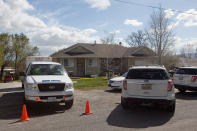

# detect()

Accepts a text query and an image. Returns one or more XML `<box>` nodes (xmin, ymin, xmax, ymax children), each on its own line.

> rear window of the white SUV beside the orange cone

<box><xmin>126</xmin><ymin>69</ymin><xmax>169</xmax><ymax>80</ymax></box>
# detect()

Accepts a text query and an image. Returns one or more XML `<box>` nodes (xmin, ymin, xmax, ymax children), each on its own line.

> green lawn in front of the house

<box><xmin>71</xmin><ymin>76</ymin><xmax>107</xmax><ymax>90</ymax></box>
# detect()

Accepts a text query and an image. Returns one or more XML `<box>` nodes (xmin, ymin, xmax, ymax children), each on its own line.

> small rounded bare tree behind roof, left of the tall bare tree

<box><xmin>126</xmin><ymin>30</ymin><xmax>147</xmax><ymax>47</ymax></box>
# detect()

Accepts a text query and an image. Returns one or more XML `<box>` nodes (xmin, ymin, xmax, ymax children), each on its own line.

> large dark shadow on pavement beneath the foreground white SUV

<box><xmin>107</xmin><ymin>105</ymin><xmax>173</xmax><ymax>128</ymax></box>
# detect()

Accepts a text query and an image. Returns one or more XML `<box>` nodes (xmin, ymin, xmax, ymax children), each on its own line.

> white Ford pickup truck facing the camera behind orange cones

<box><xmin>20</xmin><ymin>62</ymin><xmax>74</xmax><ymax>108</ymax></box>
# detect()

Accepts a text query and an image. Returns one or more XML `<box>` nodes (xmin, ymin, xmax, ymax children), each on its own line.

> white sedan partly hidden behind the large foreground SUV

<box><xmin>108</xmin><ymin>73</ymin><xmax>127</xmax><ymax>89</ymax></box>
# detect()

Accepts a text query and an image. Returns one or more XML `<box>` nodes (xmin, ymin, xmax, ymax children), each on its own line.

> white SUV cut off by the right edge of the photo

<box><xmin>174</xmin><ymin>67</ymin><xmax>197</xmax><ymax>92</ymax></box>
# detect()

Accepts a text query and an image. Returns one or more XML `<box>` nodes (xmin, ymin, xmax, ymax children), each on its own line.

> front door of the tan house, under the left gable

<box><xmin>77</xmin><ymin>58</ymin><xmax>85</xmax><ymax>76</ymax></box>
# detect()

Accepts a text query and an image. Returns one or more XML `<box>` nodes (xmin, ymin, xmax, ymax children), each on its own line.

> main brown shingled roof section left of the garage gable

<box><xmin>51</xmin><ymin>43</ymin><xmax>154</xmax><ymax>58</ymax></box>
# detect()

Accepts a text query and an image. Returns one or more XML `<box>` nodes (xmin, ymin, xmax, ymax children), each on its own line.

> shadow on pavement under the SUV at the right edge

<box><xmin>175</xmin><ymin>92</ymin><xmax>197</xmax><ymax>100</ymax></box>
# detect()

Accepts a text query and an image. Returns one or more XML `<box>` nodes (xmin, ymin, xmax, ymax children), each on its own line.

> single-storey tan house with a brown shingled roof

<box><xmin>51</xmin><ymin>43</ymin><xmax>157</xmax><ymax>76</ymax></box>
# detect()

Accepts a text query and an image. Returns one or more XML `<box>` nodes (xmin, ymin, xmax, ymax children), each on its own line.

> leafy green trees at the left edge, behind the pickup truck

<box><xmin>0</xmin><ymin>33</ymin><xmax>39</xmax><ymax>80</ymax></box>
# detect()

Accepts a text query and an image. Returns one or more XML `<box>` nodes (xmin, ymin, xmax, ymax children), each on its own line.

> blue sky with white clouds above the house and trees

<box><xmin>0</xmin><ymin>0</ymin><xmax>197</xmax><ymax>56</ymax></box>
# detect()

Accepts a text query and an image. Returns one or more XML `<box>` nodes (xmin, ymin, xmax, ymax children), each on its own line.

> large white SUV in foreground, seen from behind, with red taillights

<box><xmin>121</xmin><ymin>66</ymin><xmax>176</xmax><ymax>113</ymax></box>
